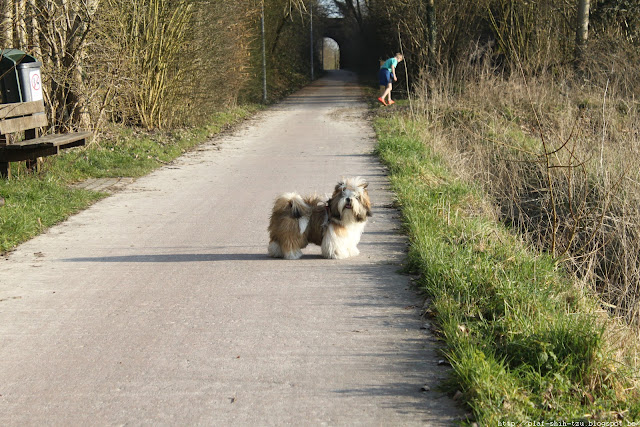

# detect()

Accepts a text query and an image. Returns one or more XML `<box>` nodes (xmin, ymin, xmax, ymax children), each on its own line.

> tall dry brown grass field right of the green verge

<box><xmin>411</xmin><ymin>49</ymin><xmax>640</xmax><ymax>328</ymax></box>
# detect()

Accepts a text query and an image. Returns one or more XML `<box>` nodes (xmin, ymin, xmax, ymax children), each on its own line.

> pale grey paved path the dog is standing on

<box><xmin>0</xmin><ymin>72</ymin><xmax>459</xmax><ymax>426</ymax></box>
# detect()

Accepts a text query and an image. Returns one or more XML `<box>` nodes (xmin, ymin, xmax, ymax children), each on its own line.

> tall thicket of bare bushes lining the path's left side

<box><xmin>0</xmin><ymin>0</ymin><xmax>315</xmax><ymax>130</ymax></box>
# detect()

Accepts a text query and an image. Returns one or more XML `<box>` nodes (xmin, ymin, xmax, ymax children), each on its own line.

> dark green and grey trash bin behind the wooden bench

<box><xmin>0</xmin><ymin>49</ymin><xmax>42</xmax><ymax>104</ymax></box>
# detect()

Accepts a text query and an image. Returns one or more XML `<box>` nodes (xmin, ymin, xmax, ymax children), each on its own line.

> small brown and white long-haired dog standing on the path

<box><xmin>268</xmin><ymin>177</ymin><xmax>371</xmax><ymax>259</ymax></box>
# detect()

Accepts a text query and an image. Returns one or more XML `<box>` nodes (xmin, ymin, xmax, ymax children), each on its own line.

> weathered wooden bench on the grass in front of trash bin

<box><xmin>0</xmin><ymin>101</ymin><xmax>92</xmax><ymax>177</ymax></box>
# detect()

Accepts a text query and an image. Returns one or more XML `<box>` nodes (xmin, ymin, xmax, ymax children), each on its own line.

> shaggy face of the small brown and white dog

<box><xmin>329</xmin><ymin>177</ymin><xmax>371</xmax><ymax>222</ymax></box>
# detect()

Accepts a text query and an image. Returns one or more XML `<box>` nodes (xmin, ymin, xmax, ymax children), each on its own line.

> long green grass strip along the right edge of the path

<box><xmin>375</xmin><ymin>114</ymin><xmax>640</xmax><ymax>425</ymax></box>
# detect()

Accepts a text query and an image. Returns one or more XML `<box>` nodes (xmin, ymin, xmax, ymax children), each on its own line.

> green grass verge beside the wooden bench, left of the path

<box><xmin>0</xmin><ymin>105</ymin><xmax>261</xmax><ymax>253</ymax></box>
